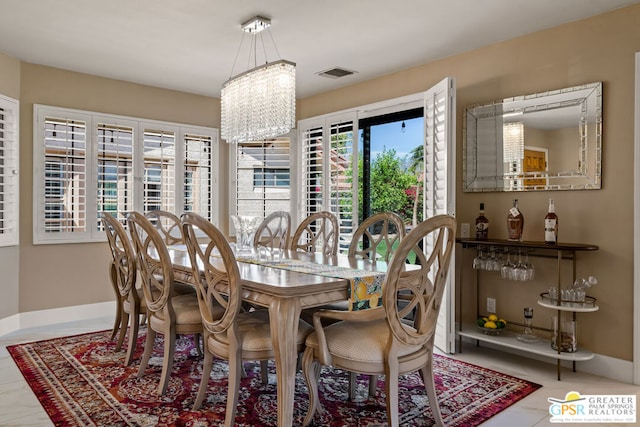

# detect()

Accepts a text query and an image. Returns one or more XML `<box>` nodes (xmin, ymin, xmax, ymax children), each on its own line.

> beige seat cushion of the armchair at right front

<box><xmin>306</xmin><ymin>319</ymin><xmax>421</xmax><ymax>363</ymax></box>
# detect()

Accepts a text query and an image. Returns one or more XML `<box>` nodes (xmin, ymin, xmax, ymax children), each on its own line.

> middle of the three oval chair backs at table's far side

<box><xmin>290</xmin><ymin>211</ymin><xmax>340</xmax><ymax>256</ymax></box>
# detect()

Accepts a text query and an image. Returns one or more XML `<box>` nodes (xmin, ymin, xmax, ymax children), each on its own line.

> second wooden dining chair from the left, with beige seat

<box><xmin>127</xmin><ymin>212</ymin><xmax>202</xmax><ymax>395</ymax></box>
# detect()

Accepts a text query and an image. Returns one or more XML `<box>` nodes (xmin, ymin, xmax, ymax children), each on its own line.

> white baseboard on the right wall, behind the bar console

<box><xmin>463</xmin><ymin>337</ymin><xmax>633</xmax><ymax>384</ymax></box>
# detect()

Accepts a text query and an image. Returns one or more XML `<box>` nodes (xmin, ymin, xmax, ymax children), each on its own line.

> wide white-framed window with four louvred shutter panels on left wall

<box><xmin>34</xmin><ymin>105</ymin><xmax>219</xmax><ymax>244</ymax></box>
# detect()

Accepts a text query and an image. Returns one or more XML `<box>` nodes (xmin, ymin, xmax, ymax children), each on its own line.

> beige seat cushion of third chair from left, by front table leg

<box><xmin>210</xmin><ymin>309</ymin><xmax>313</xmax><ymax>352</ymax></box>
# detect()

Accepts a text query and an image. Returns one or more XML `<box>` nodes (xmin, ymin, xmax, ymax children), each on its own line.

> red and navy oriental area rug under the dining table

<box><xmin>8</xmin><ymin>329</ymin><xmax>541</xmax><ymax>427</ymax></box>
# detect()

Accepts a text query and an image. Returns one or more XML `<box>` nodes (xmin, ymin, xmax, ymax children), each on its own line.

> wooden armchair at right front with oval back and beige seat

<box><xmin>302</xmin><ymin>215</ymin><xmax>456</xmax><ymax>427</ymax></box>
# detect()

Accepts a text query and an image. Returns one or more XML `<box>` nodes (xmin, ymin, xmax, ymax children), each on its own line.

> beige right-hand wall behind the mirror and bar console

<box><xmin>299</xmin><ymin>6</ymin><xmax>640</xmax><ymax>360</ymax></box>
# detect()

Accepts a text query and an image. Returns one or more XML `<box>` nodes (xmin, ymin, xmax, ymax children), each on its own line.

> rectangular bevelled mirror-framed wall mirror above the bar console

<box><xmin>463</xmin><ymin>82</ymin><xmax>602</xmax><ymax>192</ymax></box>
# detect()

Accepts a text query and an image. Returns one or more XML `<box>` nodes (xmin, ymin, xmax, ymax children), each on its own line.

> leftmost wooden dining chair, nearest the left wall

<box><xmin>102</xmin><ymin>212</ymin><xmax>147</xmax><ymax>366</ymax></box>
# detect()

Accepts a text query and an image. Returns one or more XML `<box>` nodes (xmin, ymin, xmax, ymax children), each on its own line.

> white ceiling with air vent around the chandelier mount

<box><xmin>0</xmin><ymin>0</ymin><xmax>640</xmax><ymax>98</ymax></box>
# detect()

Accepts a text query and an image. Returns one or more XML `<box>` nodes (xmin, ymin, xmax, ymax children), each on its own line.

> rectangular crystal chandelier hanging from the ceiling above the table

<box><xmin>221</xmin><ymin>17</ymin><xmax>296</xmax><ymax>143</ymax></box>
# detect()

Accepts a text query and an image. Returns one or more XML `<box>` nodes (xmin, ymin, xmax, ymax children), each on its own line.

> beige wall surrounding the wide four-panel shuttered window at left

<box><xmin>19</xmin><ymin>63</ymin><xmax>226</xmax><ymax>312</ymax></box>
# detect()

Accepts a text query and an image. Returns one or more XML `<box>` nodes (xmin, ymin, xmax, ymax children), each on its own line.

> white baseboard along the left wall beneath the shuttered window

<box><xmin>0</xmin><ymin>301</ymin><xmax>116</xmax><ymax>336</ymax></box>
